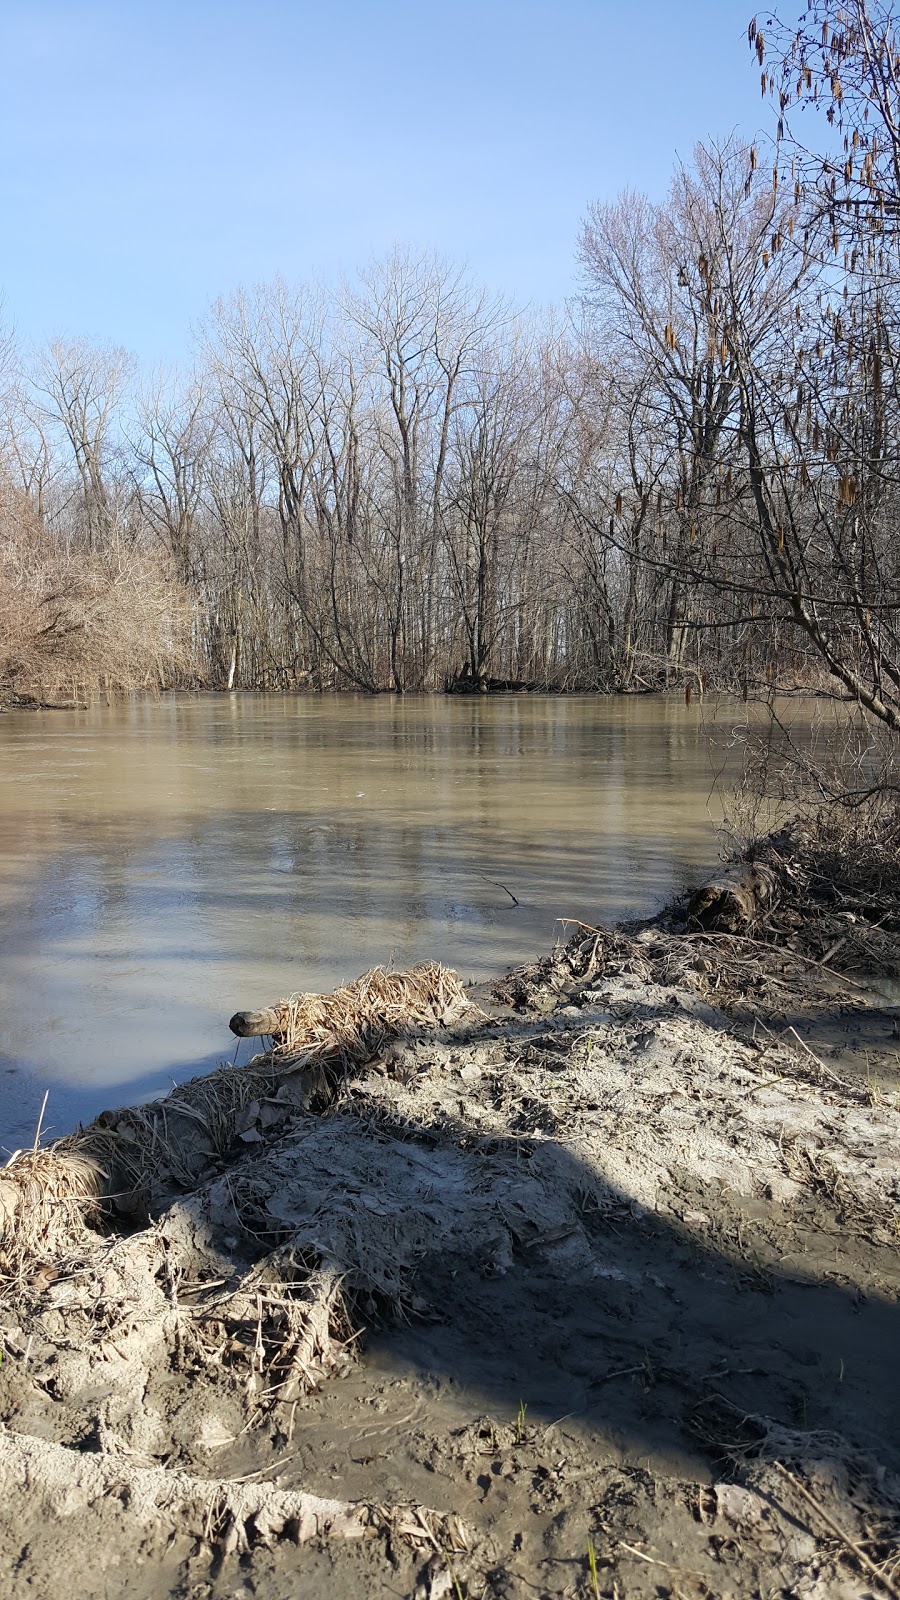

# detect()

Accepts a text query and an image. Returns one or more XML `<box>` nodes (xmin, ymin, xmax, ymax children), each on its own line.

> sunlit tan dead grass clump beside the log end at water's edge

<box><xmin>274</xmin><ymin>962</ymin><xmax>476</xmax><ymax>1070</ymax></box>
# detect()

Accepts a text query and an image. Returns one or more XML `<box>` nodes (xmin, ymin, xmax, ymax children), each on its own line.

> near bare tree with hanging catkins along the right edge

<box><xmin>717</xmin><ymin>0</ymin><xmax>900</xmax><ymax>731</ymax></box>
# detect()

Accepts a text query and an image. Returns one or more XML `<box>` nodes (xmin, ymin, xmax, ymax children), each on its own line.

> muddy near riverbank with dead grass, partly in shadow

<box><xmin>0</xmin><ymin>838</ymin><xmax>900</xmax><ymax>1600</ymax></box>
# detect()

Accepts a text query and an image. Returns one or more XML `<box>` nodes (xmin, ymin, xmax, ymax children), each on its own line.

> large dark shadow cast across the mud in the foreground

<box><xmin>180</xmin><ymin>1056</ymin><xmax>900</xmax><ymax>1472</ymax></box>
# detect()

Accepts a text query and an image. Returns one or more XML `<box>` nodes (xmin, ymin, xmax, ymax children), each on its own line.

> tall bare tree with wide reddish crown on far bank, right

<box><xmin>573</xmin><ymin>131</ymin><xmax>806</xmax><ymax>688</ymax></box>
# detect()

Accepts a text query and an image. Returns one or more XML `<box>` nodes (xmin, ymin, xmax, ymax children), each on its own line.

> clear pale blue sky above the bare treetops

<box><xmin>0</xmin><ymin>0</ymin><xmax>771</xmax><ymax>362</ymax></box>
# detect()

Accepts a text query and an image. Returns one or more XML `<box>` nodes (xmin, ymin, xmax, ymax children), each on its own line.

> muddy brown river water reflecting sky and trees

<box><xmin>0</xmin><ymin>694</ymin><xmax>740</xmax><ymax>1149</ymax></box>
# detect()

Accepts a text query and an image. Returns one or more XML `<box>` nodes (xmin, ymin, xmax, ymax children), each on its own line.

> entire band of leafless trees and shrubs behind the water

<box><xmin>0</xmin><ymin>0</ymin><xmax>900</xmax><ymax>730</ymax></box>
